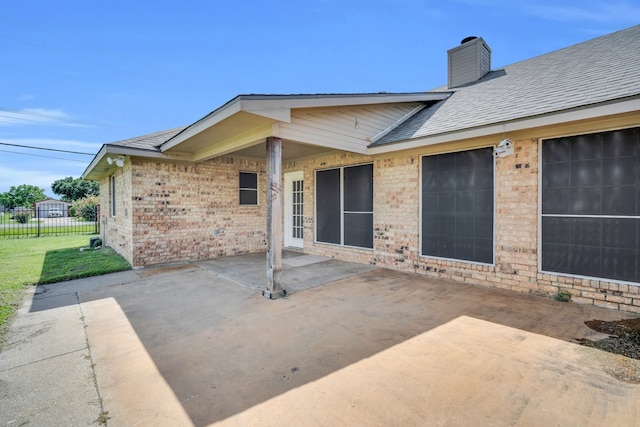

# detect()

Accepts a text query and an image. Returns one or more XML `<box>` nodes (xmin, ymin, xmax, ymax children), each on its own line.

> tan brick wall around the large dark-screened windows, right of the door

<box><xmin>298</xmin><ymin>138</ymin><xmax>640</xmax><ymax>313</ymax></box>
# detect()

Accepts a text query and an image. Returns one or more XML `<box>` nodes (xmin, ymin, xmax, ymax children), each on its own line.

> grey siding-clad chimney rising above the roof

<box><xmin>447</xmin><ymin>36</ymin><xmax>491</xmax><ymax>89</ymax></box>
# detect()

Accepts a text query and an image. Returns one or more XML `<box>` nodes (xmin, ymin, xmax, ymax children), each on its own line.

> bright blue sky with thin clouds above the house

<box><xmin>0</xmin><ymin>0</ymin><xmax>640</xmax><ymax>196</ymax></box>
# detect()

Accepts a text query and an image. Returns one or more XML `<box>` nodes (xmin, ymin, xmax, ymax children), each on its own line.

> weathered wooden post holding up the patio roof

<box><xmin>262</xmin><ymin>137</ymin><xmax>287</xmax><ymax>299</ymax></box>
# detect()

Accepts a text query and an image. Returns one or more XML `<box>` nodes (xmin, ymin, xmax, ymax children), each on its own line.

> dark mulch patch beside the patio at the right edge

<box><xmin>579</xmin><ymin>318</ymin><xmax>640</xmax><ymax>360</ymax></box>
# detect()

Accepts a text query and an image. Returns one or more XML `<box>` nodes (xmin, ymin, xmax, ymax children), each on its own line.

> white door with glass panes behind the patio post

<box><xmin>284</xmin><ymin>171</ymin><xmax>304</xmax><ymax>248</ymax></box>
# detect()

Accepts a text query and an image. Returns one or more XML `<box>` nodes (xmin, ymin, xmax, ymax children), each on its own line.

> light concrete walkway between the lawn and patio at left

<box><xmin>0</xmin><ymin>271</ymin><xmax>140</xmax><ymax>426</ymax></box>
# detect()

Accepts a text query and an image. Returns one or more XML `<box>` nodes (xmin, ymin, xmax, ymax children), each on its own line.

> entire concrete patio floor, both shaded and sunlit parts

<box><xmin>0</xmin><ymin>256</ymin><xmax>640</xmax><ymax>426</ymax></box>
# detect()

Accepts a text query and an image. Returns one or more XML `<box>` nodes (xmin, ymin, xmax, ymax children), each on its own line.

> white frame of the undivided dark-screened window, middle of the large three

<box><xmin>418</xmin><ymin>146</ymin><xmax>497</xmax><ymax>267</ymax></box>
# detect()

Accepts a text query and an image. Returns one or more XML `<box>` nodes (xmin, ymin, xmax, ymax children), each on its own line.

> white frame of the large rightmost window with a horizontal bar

<box><xmin>536</xmin><ymin>125</ymin><xmax>640</xmax><ymax>286</ymax></box>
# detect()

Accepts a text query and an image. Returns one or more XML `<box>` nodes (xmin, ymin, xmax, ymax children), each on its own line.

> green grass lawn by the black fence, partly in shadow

<box><xmin>0</xmin><ymin>235</ymin><xmax>131</xmax><ymax>342</ymax></box>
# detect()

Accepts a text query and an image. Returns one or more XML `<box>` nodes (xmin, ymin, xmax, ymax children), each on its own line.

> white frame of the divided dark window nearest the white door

<box><xmin>313</xmin><ymin>162</ymin><xmax>375</xmax><ymax>251</ymax></box>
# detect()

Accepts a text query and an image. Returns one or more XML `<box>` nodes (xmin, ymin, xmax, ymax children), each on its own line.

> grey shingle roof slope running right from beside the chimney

<box><xmin>371</xmin><ymin>25</ymin><xmax>640</xmax><ymax>146</ymax></box>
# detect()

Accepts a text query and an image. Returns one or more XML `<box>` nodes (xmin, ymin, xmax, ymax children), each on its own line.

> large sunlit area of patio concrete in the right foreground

<box><xmin>216</xmin><ymin>316</ymin><xmax>640</xmax><ymax>426</ymax></box>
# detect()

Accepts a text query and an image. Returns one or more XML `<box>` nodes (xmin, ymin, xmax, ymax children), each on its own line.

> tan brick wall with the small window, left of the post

<box><xmin>101</xmin><ymin>157</ymin><xmax>266</xmax><ymax>266</ymax></box>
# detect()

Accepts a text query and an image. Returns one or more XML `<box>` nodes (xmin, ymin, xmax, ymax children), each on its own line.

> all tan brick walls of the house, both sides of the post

<box><xmin>101</xmin><ymin>138</ymin><xmax>640</xmax><ymax>313</ymax></box>
